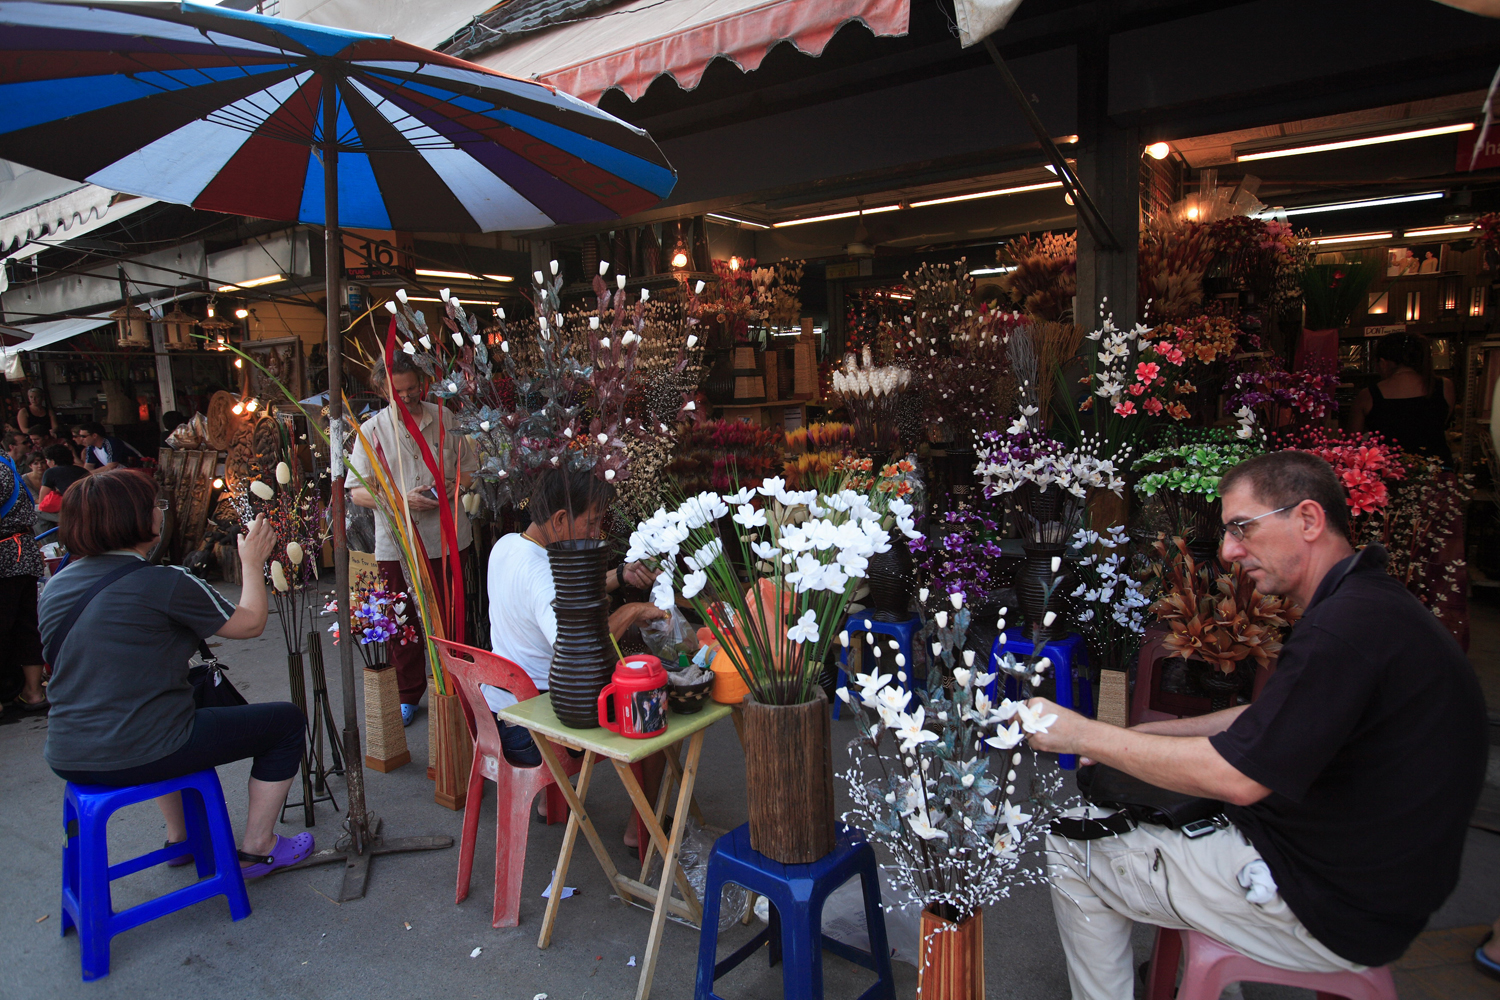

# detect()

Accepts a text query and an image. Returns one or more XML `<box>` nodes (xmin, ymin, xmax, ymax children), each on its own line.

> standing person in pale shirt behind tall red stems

<box><xmin>344</xmin><ymin>351</ymin><xmax>479</xmax><ymax>726</ymax></box>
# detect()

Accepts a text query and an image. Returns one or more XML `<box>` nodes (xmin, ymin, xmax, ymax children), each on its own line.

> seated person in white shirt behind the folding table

<box><xmin>485</xmin><ymin>469</ymin><xmax>666</xmax><ymax>847</ymax></box>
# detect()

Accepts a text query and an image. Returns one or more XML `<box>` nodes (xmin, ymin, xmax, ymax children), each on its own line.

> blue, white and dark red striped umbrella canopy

<box><xmin>0</xmin><ymin>0</ymin><xmax>675</xmax><ymax>232</ymax></box>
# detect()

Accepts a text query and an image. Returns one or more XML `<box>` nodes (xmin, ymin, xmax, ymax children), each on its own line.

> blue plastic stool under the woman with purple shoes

<box><xmin>63</xmin><ymin>768</ymin><xmax>251</xmax><ymax>982</ymax></box>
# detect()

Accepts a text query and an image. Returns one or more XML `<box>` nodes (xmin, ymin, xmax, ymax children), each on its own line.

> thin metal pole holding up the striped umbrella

<box><xmin>321</xmin><ymin>73</ymin><xmax>371</xmax><ymax>855</ymax></box>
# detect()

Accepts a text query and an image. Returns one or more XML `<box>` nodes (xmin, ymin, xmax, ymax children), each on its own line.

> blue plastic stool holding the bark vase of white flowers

<box><xmin>693</xmin><ymin>823</ymin><xmax>896</xmax><ymax>1000</ymax></box>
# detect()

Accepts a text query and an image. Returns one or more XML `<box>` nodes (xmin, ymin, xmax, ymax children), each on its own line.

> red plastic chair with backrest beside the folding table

<box><xmin>434</xmin><ymin>639</ymin><xmax>579</xmax><ymax>927</ymax></box>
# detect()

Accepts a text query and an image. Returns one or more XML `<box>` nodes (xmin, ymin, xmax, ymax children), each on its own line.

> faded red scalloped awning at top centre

<box><xmin>474</xmin><ymin>0</ymin><xmax>911</xmax><ymax>105</ymax></box>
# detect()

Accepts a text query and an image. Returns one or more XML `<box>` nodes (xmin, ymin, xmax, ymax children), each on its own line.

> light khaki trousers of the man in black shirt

<box><xmin>1047</xmin><ymin>826</ymin><xmax>1364</xmax><ymax>1000</ymax></box>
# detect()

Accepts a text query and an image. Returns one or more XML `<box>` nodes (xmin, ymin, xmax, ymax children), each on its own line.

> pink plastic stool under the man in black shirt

<box><xmin>1146</xmin><ymin>927</ymin><xmax>1397</xmax><ymax>1000</ymax></box>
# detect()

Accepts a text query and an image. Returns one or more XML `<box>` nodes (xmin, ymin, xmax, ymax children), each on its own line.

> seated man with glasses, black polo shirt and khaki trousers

<box><xmin>1031</xmin><ymin>451</ymin><xmax>1487</xmax><ymax>1000</ymax></box>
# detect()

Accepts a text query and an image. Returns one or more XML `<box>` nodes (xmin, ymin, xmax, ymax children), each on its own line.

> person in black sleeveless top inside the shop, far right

<box><xmin>1349</xmin><ymin>333</ymin><xmax>1454</xmax><ymax>466</ymax></box>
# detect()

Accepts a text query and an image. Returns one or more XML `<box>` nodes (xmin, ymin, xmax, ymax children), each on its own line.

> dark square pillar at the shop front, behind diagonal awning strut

<box><xmin>1074</xmin><ymin>36</ymin><xmax>1140</xmax><ymax>330</ymax></box>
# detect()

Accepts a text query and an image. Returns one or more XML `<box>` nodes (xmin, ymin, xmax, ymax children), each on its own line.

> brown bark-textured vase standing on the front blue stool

<box><xmin>744</xmin><ymin>690</ymin><xmax>837</xmax><ymax>865</ymax></box>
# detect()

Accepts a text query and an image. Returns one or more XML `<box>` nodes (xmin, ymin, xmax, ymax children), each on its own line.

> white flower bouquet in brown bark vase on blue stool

<box><xmin>626</xmin><ymin>478</ymin><xmax>917</xmax><ymax>864</ymax></box>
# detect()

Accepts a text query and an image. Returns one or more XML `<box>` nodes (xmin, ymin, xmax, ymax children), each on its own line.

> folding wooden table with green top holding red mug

<box><xmin>500</xmin><ymin>694</ymin><xmax>732</xmax><ymax>1000</ymax></box>
